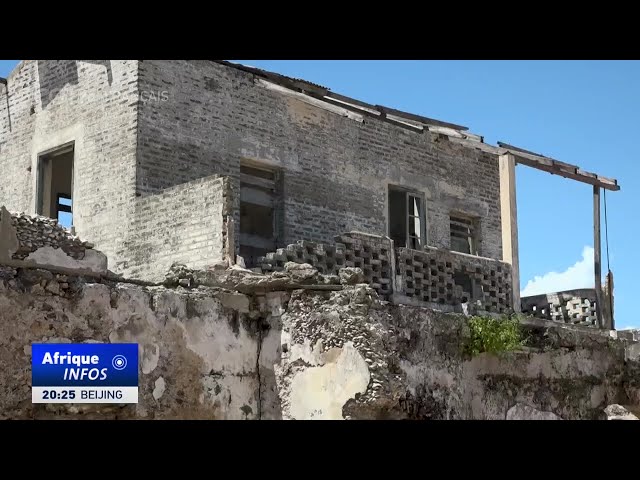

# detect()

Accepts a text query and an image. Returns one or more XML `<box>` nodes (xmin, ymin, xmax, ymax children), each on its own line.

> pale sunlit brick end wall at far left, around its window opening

<box><xmin>0</xmin><ymin>60</ymin><xmax>139</xmax><ymax>274</ymax></box>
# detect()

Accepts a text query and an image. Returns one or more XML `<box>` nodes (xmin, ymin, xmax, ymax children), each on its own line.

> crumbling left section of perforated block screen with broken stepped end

<box><xmin>258</xmin><ymin>232</ymin><xmax>393</xmax><ymax>298</ymax></box>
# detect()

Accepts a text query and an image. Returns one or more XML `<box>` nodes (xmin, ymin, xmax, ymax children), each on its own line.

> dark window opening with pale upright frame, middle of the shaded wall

<box><xmin>389</xmin><ymin>186</ymin><xmax>426</xmax><ymax>250</ymax></box>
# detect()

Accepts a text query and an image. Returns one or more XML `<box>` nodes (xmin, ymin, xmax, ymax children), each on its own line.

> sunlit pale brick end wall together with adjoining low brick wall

<box><xmin>0</xmin><ymin>60</ymin><xmax>234</xmax><ymax>280</ymax></box>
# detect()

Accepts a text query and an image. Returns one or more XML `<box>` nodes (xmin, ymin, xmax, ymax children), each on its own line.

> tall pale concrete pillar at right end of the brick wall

<box><xmin>499</xmin><ymin>154</ymin><xmax>520</xmax><ymax>312</ymax></box>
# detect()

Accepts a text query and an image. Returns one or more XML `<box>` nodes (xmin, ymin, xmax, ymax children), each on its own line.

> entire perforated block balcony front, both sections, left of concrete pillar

<box><xmin>259</xmin><ymin>232</ymin><xmax>513</xmax><ymax>313</ymax></box>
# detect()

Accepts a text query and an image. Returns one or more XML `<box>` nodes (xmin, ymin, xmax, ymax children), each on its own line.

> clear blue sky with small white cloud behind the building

<box><xmin>0</xmin><ymin>60</ymin><xmax>640</xmax><ymax>328</ymax></box>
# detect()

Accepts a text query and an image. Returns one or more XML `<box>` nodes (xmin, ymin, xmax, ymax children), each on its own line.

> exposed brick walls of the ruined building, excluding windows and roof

<box><xmin>0</xmin><ymin>60</ymin><xmax>502</xmax><ymax>288</ymax></box>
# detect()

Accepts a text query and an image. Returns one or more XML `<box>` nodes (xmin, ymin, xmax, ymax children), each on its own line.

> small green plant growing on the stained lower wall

<box><xmin>465</xmin><ymin>317</ymin><xmax>524</xmax><ymax>356</ymax></box>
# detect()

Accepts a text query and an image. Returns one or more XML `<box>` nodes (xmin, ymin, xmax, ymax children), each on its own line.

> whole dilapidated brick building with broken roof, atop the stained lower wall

<box><xmin>0</xmin><ymin>60</ymin><xmax>619</xmax><ymax>327</ymax></box>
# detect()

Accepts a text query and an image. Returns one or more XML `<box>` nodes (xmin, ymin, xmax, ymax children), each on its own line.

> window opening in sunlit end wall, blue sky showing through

<box><xmin>36</xmin><ymin>144</ymin><xmax>74</xmax><ymax>229</ymax></box>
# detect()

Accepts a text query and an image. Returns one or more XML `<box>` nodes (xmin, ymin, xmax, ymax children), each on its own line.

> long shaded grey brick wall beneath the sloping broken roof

<box><xmin>137</xmin><ymin>60</ymin><xmax>502</xmax><ymax>258</ymax></box>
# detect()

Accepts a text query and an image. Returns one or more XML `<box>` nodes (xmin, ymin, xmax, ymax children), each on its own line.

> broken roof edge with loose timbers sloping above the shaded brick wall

<box><xmin>212</xmin><ymin>60</ymin><xmax>469</xmax><ymax>132</ymax></box>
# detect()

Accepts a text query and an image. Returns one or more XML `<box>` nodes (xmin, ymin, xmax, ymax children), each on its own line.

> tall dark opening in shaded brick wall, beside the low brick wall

<box><xmin>239</xmin><ymin>165</ymin><xmax>283</xmax><ymax>268</ymax></box>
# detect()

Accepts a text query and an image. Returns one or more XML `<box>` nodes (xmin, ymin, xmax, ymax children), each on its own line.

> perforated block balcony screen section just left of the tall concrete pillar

<box><xmin>396</xmin><ymin>247</ymin><xmax>512</xmax><ymax>313</ymax></box>
